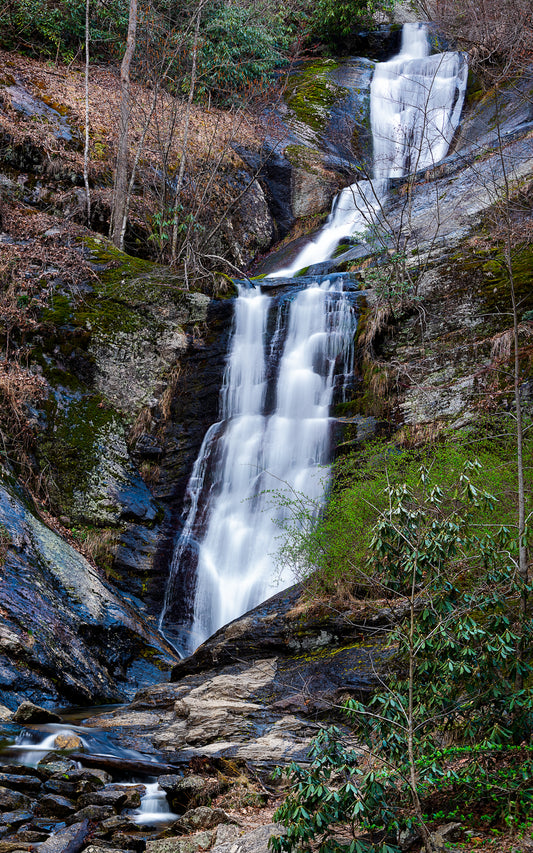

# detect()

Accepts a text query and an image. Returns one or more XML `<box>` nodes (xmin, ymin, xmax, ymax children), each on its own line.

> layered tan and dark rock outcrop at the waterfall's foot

<box><xmin>77</xmin><ymin>586</ymin><xmax>391</xmax><ymax>770</ymax></box>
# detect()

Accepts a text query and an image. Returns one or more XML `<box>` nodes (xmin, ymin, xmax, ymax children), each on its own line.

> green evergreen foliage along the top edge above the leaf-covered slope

<box><xmin>0</xmin><ymin>0</ymin><xmax>388</xmax><ymax>95</ymax></box>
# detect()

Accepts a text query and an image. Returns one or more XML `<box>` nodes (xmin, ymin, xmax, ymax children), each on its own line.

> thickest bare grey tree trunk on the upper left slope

<box><xmin>109</xmin><ymin>0</ymin><xmax>137</xmax><ymax>249</ymax></box>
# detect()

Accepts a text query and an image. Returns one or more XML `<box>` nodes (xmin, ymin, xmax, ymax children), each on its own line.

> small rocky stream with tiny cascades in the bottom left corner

<box><xmin>0</xmin><ymin>708</ymin><xmax>181</xmax><ymax>836</ymax></box>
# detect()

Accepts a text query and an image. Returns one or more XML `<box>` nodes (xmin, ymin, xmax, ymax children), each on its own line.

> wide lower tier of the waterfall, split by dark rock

<box><xmin>160</xmin><ymin>278</ymin><xmax>355</xmax><ymax>651</ymax></box>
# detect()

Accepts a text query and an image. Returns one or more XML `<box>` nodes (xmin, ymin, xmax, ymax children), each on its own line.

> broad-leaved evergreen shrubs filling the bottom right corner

<box><xmin>273</xmin><ymin>462</ymin><xmax>533</xmax><ymax>853</ymax></box>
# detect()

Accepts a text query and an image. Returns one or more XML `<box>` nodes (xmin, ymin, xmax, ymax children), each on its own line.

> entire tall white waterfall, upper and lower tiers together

<box><xmin>159</xmin><ymin>24</ymin><xmax>468</xmax><ymax>655</ymax></box>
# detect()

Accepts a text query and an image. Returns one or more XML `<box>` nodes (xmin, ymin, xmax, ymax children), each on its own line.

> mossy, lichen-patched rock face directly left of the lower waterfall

<box><xmin>25</xmin><ymin>238</ymin><xmax>234</xmax><ymax>610</ymax></box>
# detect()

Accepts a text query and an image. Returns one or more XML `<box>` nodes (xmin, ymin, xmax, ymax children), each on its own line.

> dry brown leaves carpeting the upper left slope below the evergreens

<box><xmin>0</xmin><ymin>46</ymin><xmax>259</xmax><ymax>188</ymax></box>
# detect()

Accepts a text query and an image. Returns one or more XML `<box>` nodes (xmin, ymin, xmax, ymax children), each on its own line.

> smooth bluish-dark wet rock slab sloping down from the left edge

<box><xmin>0</xmin><ymin>476</ymin><xmax>179</xmax><ymax>708</ymax></box>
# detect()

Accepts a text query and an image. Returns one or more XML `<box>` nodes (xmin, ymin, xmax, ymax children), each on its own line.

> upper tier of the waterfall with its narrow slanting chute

<box><xmin>269</xmin><ymin>24</ymin><xmax>468</xmax><ymax>278</ymax></box>
